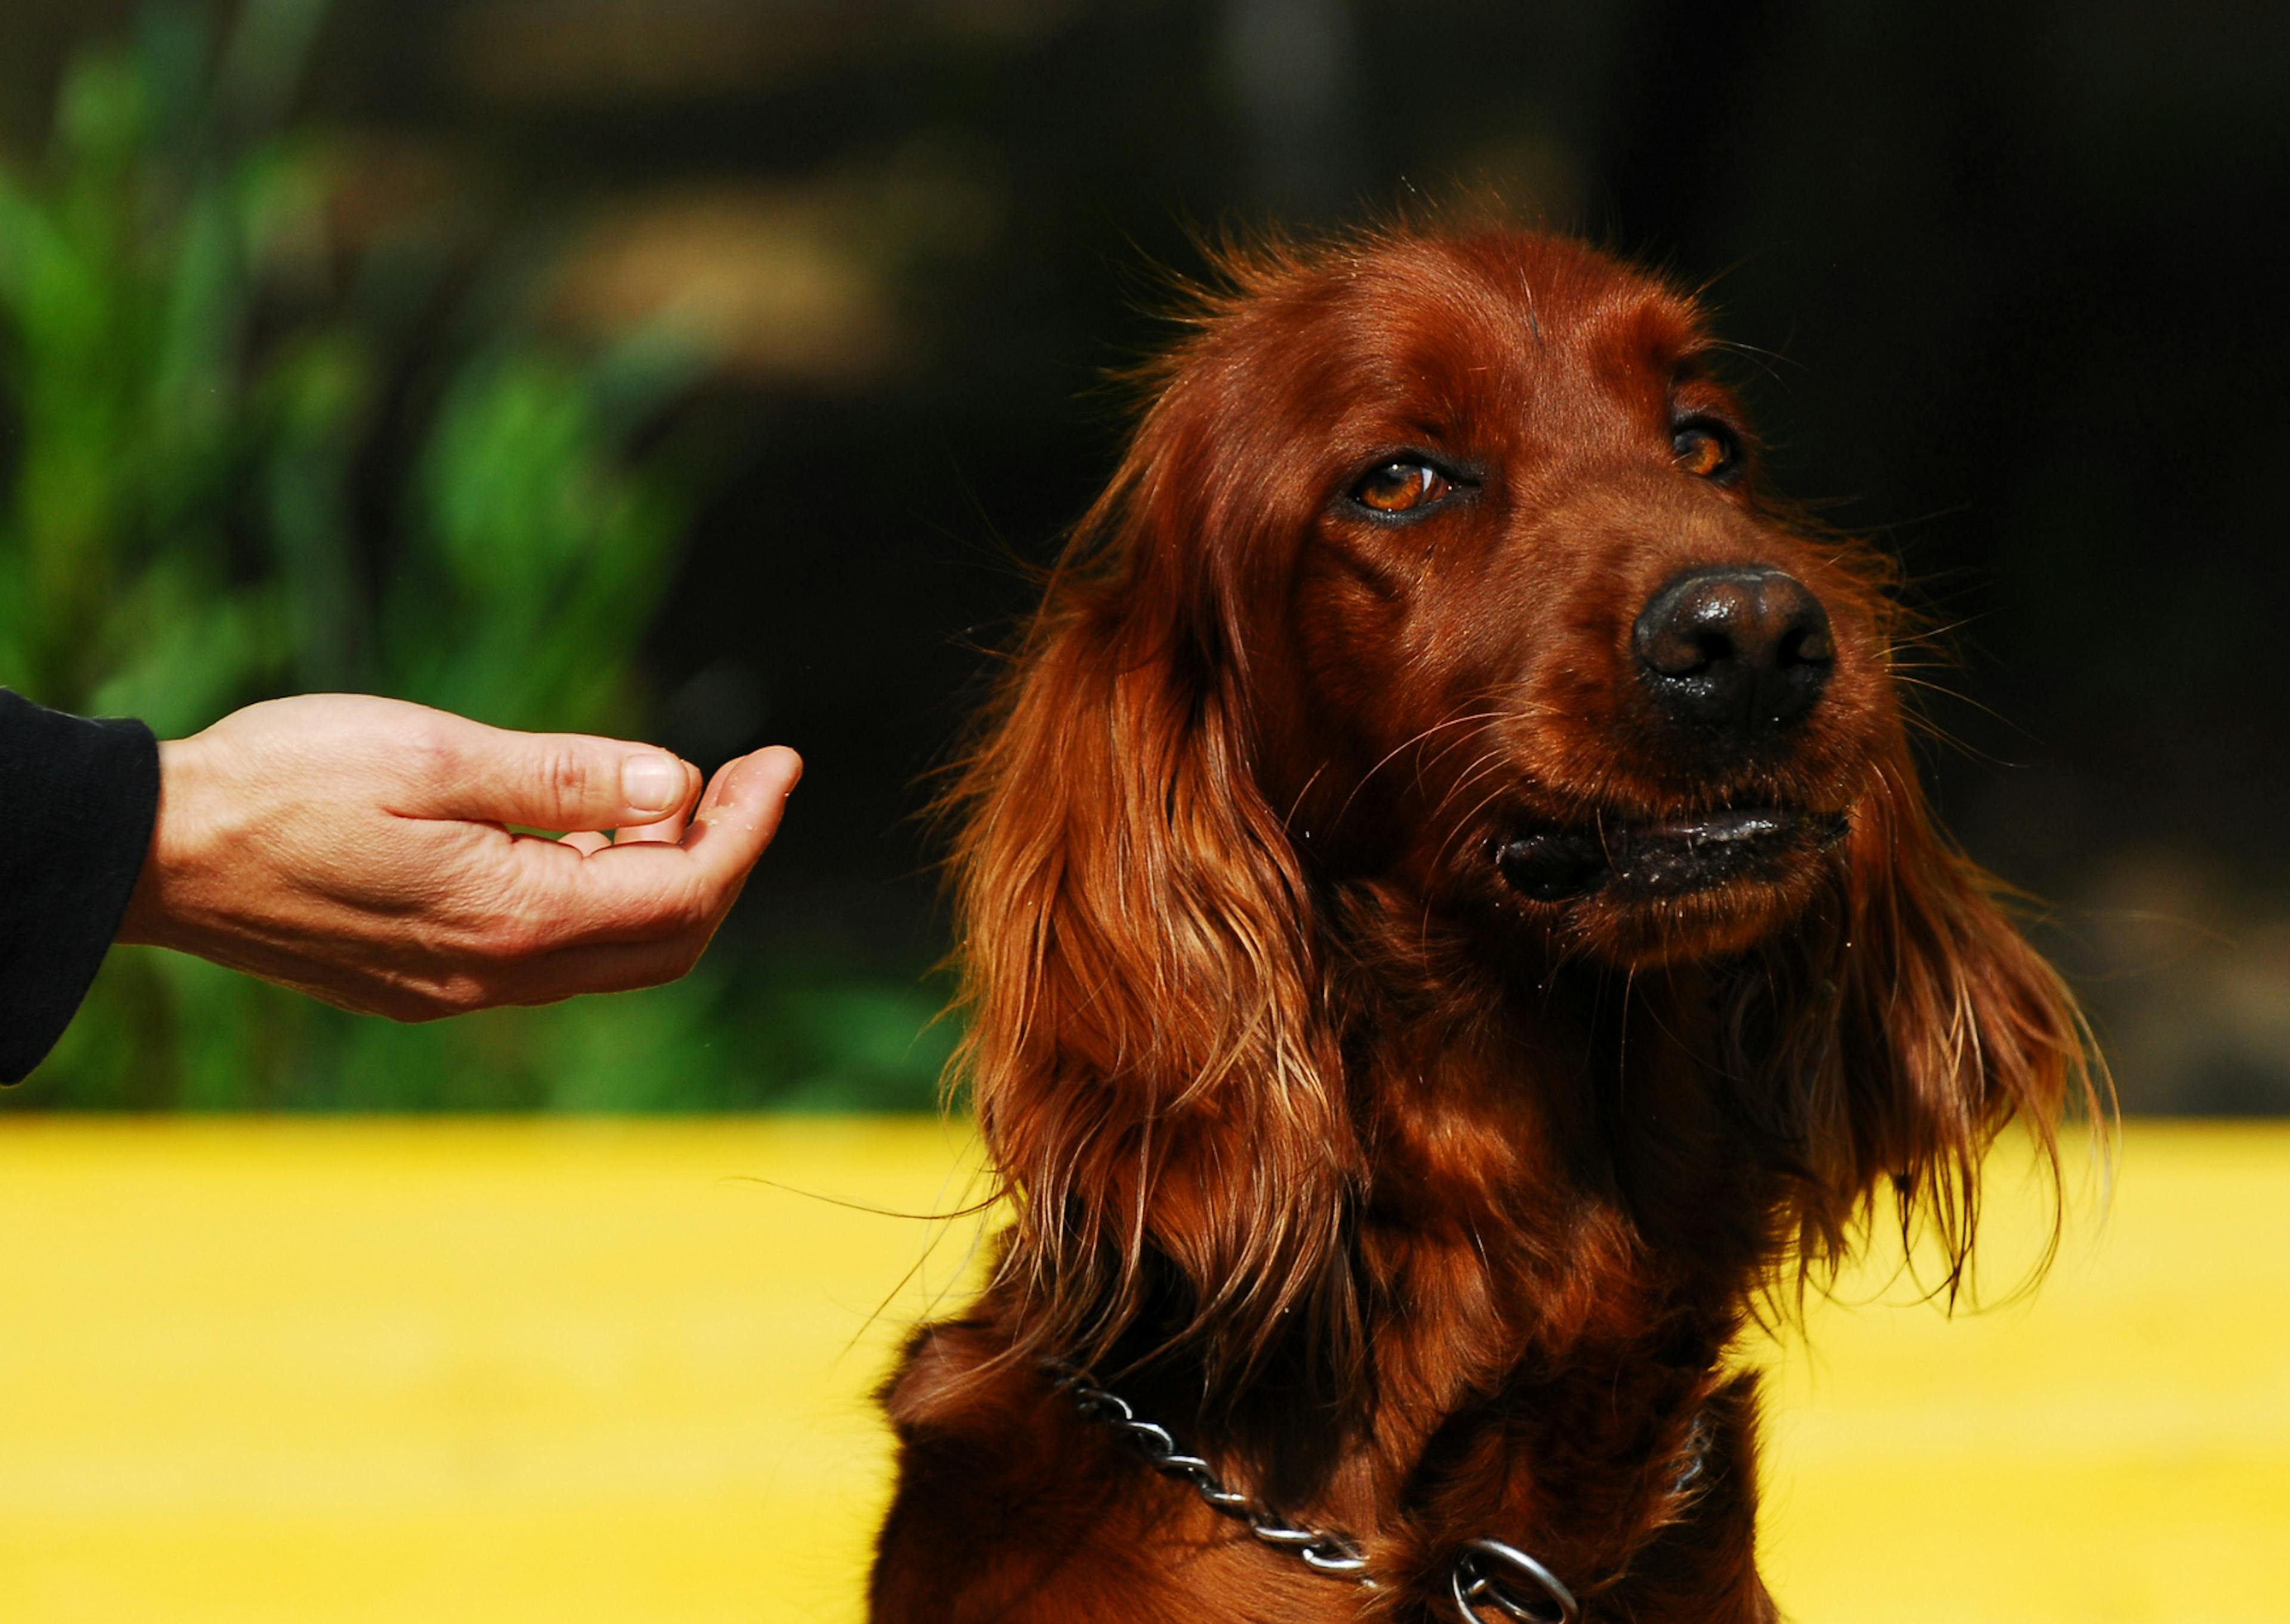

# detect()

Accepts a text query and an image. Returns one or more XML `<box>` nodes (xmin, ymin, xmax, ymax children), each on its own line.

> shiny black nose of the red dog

<box><xmin>1630</xmin><ymin>563</ymin><xmax>1837</xmax><ymax>745</ymax></box>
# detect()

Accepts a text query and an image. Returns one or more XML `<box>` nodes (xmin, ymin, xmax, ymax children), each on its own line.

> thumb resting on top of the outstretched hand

<box><xmin>398</xmin><ymin>712</ymin><xmax>701</xmax><ymax>832</ymax></box>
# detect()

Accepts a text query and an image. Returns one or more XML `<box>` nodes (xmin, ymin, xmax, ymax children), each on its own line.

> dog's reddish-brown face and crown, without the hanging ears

<box><xmin>1117</xmin><ymin>234</ymin><xmax>1901</xmax><ymax>964</ymax></box>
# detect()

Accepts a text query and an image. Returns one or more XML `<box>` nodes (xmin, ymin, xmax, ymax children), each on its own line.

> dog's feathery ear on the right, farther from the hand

<box><xmin>1729</xmin><ymin>747</ymin><xmax>2105</xmax><ymax>1301</ymax></box>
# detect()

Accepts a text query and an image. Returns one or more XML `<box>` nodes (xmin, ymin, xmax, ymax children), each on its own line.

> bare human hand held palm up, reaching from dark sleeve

<box><xmin>119</xmin><ymin>694</ymin><xmax>804</xmax><ymax>1022</ymax></box>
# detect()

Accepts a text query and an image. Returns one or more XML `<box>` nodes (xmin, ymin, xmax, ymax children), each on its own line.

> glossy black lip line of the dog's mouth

<box><xmin>1496</xmin><ymin>806</ymin><xmax>1848</xmax><ymax>903</ymax></box>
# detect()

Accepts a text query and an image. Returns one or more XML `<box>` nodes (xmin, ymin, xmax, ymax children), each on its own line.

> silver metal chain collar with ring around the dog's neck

<box><xmin>1047</xmin><ymin>1363</ymin><xmax>1710</xmax><ymax>1624</ymax></box>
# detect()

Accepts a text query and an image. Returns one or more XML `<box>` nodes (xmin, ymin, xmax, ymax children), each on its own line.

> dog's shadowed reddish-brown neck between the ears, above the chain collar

<box><xmin>1181</xmin><ymin>879</ymin><xmax>1777</xmax><ymax>1526</ymax></box>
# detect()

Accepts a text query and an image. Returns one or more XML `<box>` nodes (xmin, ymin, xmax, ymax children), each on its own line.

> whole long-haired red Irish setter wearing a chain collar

<box><xmin>872</xmin><ymin>229</ymin><xmax>2088</xmax><ymax>1624</ymax></box>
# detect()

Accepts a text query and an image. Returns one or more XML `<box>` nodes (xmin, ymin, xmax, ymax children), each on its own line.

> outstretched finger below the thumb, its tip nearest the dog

<box><xmin>497</xmin><ymin>749</ymin><xmax>804</xmax><ymax>953</ymax></box>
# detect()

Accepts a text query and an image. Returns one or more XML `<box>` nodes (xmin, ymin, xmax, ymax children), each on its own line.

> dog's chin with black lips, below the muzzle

<box><xmin>1493</xmin><ymin>806</ymin><xmax>1850</xmax><ymax>964</ymax></box>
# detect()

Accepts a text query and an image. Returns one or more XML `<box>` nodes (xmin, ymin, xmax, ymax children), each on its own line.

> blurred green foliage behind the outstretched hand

<box><xmin>0</xmin><ymin>0</ymin><xmax>946</xmax><ymax>1109</ymax></box>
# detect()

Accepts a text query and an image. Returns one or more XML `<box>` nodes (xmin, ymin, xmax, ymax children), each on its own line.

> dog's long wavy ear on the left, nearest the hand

<box><xmin>952</xmin><ymin>444</ymin><xmax>1356</xmax><ymax>1381</ymax></box>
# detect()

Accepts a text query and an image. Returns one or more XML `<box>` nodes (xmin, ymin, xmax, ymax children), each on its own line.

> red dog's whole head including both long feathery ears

<box><xmin>957</xmin><ymin>231</ymin><xmax>2082</xmax><ymax>1365</ymax></box>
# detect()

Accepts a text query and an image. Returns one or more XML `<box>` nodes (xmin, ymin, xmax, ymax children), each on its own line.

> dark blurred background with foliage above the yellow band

<box><xmin>0</xmin><ymin>0</ymin><xmax>2290</xmax><ymax>1113</ymax></box>
